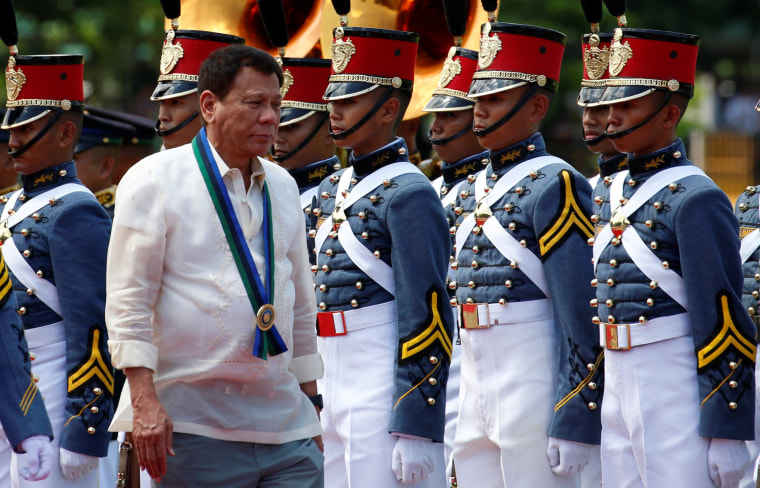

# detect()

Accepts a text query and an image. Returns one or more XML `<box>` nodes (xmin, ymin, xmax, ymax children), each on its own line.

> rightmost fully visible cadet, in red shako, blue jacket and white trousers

<box><xmin>594</xmin><ymin>29</ymin><xmax>756</xmax><ymax>487</ymax></box>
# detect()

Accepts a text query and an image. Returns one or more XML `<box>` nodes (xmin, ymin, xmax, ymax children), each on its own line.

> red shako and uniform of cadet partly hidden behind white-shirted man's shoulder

<box><xmin>272</xmin><ymin>58</ymin><xmax>340</xmax><ymax>264</ymax></box>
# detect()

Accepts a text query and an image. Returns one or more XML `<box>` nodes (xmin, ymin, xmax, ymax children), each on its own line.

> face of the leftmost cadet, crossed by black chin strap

<box><xmin>8</xmin><ymin>113</ymin><xmax>61</xmax><ymax>175</ymax></box>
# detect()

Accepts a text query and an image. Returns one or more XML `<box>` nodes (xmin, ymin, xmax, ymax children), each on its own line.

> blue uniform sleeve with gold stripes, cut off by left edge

<box><xmin>0</xmin><ymin>248</ymin><xmax>57</xmax><ymax>488</ymax></box>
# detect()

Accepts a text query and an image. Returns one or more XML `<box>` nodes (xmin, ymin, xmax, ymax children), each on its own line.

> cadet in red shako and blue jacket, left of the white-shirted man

<box><xmin>0</xmin><ymin>43</ymin><xmax>114</xmax><ymax>488</ymax></box>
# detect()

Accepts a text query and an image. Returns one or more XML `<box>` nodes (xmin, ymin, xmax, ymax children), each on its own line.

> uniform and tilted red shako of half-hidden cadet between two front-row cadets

<box><xmin>422</xmin><ymin>43</ymin><xmax>488</xmax><ymax>476</ymax></box>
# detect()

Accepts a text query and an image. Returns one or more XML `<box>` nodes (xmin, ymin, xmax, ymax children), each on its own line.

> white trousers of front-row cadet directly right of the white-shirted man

<box><xmin>317</xmin><ymin>323</ymin><xmax>446</xmax><ymax>488</ymax></box>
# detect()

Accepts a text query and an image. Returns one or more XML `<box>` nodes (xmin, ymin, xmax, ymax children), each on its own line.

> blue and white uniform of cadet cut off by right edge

<box><xmin>734</xmin><ymin>186</ymin><xmax>760</xmax><ymax>488</ymax></box>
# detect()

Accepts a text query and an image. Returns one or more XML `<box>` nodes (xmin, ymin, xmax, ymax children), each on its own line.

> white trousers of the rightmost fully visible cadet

<box><xmin>602</xmin><ymin>336</ymin><xmax>714</xmax><ymax>488</ymax></box>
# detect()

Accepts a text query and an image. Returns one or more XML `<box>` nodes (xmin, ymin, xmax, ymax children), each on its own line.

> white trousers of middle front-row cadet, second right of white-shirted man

<box><xmin>454</xmin><ymin>319</ymin><xmax>578</xmax><ymax>488</ymax></box>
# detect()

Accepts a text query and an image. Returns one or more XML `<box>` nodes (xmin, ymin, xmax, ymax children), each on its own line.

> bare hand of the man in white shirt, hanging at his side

<box><xmin>124</xmin><ymin>368</ymin><xmax>174</xmax><ymax>481</ymax></box>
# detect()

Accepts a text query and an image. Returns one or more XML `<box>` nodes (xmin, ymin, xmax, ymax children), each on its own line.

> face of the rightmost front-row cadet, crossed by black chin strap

<box><xmin>607</xmin><ymin>92</ymin><xmax>672</xmax><ymax>155</ymax></box>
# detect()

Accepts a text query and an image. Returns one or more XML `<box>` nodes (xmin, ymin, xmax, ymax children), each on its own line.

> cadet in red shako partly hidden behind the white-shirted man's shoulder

<box><xmin>272</xmin><ymin>58</ymin><xmax>340</xmax><ymax>258</ymax></box>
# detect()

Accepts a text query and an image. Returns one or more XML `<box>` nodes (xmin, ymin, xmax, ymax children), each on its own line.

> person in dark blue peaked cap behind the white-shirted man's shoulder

<box><xmin>74</xmin><ymin>114</ymin><xmax>134</xmax><ymax>219</ymax></box>
